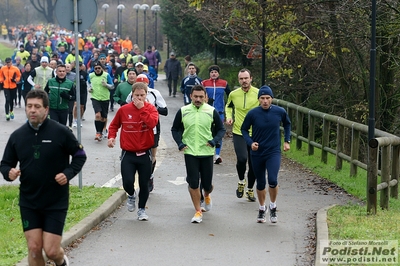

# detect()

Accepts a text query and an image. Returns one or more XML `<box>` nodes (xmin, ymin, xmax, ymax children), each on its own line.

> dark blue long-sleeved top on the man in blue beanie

<box><xmin>241</xmin><ymin>104</ymin><xmax>291</xmax><ymax>156</ymax></box>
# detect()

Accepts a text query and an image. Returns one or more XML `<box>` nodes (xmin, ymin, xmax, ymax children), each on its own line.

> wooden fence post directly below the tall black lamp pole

<box><xmin>367</xmin><ymin>139</ymin><xmax>379</xmax><ymax>214</ymax></box>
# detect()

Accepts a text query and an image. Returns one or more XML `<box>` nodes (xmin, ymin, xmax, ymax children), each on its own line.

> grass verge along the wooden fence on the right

<box><xmin>285</xmin><ymin>143</ymin><xmax>400</xmax><ymax>244</ymax></box>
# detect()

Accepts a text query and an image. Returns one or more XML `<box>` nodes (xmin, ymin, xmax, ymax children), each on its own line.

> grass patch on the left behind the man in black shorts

<box><xmin>0</xmin><ymin>185</ymin><xmax>118</xmax><ymax>266</ymax></box>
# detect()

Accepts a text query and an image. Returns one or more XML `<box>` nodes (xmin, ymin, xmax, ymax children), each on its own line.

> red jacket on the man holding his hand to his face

<box><xmin>108</xmin><ymin>102</ymin><xmax>158</xmax><ymax>152</ymax></box>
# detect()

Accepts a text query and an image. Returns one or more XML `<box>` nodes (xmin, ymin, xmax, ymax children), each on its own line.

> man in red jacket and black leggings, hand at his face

<box><xmin>108</xmin><ymin>82</ymin><xmax>158</xmax><ymax>221</ymax></box>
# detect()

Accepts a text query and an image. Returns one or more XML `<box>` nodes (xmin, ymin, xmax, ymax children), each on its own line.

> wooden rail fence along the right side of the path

<box><xmin>273</xmin><ymin>99</ymin><xmax>400</xmax><ymax>214</ymax></box>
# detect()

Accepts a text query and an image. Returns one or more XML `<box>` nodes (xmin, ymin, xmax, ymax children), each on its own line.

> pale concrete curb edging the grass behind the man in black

<box><xmin>15</xmin><ymin>190</ymin><xmax>127</xmax><ymax>266</ymax></box>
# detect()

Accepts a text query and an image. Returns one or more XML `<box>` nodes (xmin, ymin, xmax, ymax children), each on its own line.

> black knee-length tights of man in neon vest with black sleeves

<box><xmin>185</xmin><ymin>154</ymin><xmax>213</xmax><ymax>192</ymax></box>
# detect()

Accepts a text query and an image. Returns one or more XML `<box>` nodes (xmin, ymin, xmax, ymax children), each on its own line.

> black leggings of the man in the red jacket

<box><xmin>121</xmin><ymin>150</ymin><xmax>152</xmax><ymax>208</ymax></box>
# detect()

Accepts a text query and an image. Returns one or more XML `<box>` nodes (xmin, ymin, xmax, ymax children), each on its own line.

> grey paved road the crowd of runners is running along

<box><xmin>0</xmin><ymin>75</ymin><xmax>348</xmax><ymax>266</ymax></box>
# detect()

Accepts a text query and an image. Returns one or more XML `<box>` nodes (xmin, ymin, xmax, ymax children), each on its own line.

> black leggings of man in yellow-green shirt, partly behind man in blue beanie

<box><xmin>233</xmin><ymin>134</ymin><xmax>256</xmax><ymax>188</ymax></box>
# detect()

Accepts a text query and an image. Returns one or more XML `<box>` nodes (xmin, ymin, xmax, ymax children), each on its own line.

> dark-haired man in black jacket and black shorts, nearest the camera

<box><xmin>0</xmin><ymin>90</ymin><xmax>86</xmax><ymax>265</ymax></box>
